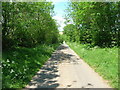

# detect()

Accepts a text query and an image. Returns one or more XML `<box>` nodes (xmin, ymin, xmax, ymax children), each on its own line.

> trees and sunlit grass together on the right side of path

<box><xmin>63</xmin><ymin>2</ymin><xmax>120</xmax><ymax>88</ymax></box>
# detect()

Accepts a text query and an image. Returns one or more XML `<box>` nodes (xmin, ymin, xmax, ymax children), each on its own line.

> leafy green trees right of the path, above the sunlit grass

<box><xmin>64</xmin><ymin>2</ymin><xmax>120</xmax><ymax>47</ymax></box>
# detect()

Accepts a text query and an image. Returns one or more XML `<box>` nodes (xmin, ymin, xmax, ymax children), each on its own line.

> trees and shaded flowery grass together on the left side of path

<box><xmin>2</xmin><ymin>2</ymin><xmax>60</xmax><ymax>88</ymax></box>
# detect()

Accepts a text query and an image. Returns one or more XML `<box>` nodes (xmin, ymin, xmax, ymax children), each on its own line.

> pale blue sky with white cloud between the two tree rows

<box><xmin>53</xmin><ymin>0</ymin><xmax>68</xmax><ymax>31</ymax></box>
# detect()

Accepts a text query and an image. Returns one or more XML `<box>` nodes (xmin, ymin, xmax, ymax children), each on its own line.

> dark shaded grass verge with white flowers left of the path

<box><xmin>2</xmin><ymin>44</ymin><xmax>59</xmax><ymax>88</ymax></box>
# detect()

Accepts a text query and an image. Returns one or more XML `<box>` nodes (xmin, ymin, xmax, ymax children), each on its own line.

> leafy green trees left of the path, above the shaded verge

<box><xmin>2</xmin><ymin>2</ymin><xmax>58</xmax><ymax>49</ymax></box>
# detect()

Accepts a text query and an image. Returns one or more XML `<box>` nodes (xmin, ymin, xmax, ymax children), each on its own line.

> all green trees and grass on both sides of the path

<box><xmin>1</xmin><ymin>2</ymin><xmax>120</xmax><ymax>88</ymax></box>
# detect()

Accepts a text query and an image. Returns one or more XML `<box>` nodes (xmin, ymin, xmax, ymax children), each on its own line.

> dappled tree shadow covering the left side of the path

<box><xmin>26</xmin><ymin>45</ymin><xmax>77</xmax><ymax>88</ymax></box>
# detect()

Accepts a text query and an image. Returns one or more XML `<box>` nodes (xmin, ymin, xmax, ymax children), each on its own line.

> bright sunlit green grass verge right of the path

<box><xmin>67</xmin><ymin>42</ymin><xmax>118</xmax><ymax>88</ymax></box>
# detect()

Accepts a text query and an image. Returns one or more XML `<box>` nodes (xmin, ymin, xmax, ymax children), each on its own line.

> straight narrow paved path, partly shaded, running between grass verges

<box><xmin>26</xmin><ymin>43</ymin><xmax>111</xmax><ymax>88</ymax></box>
